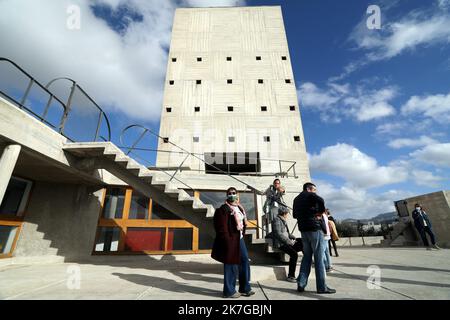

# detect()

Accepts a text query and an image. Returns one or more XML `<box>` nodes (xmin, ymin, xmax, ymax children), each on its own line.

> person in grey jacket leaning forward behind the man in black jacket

<box><xmin>272</xmin><ymin>206</ymin><xmax>303</xmax><ymax>282</ymax></box>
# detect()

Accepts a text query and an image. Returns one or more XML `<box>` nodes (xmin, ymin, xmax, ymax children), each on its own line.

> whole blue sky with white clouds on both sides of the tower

<box><xmin>0</xmin><ymin>0</ymin><xmax>450</xmax><ymax>217</ymax></box>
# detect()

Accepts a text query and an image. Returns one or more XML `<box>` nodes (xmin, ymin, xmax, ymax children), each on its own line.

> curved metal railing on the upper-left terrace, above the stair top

<box><xmin>0</xmin><ymin>57</ymin><xmax>111</xmax><ymax>142</ymax></box>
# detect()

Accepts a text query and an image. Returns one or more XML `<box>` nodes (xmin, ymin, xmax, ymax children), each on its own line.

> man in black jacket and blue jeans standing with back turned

<box><xmin>293</xmin><ymin>182</ymin><xmax>336</xmax><ymax>293</ymax></box>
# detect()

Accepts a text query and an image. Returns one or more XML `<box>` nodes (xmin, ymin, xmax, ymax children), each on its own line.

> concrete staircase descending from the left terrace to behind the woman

<box><xmin>63</xmin><ymin>142</ymin><xmax>270</xmax><ymax>252</ymax></box>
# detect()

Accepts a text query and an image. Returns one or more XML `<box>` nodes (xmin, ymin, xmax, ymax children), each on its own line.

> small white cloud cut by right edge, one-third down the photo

<box><xmin>401</xmin><ymin>93</ymin><xmax>450</xmax><ymax>123</ymax></box>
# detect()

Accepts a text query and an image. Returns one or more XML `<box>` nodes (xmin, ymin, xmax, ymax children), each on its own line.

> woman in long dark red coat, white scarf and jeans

<box><xmin>211</xmin><ymin>187</ymin><xmax>255</xmax><ymax>298</ymax></box>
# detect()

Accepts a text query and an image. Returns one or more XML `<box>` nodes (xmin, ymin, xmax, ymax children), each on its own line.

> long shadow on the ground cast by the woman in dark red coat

<box><xmin>112</xmin><ymin>272</ymin><xmax>222</xmax><ymax>297</ymax></box>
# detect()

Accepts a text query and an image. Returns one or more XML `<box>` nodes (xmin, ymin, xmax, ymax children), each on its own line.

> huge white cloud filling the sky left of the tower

<box><xmin>0</xmin><ymin>0</ymin><xmax>243</xmax><ymax>122</ymax></box>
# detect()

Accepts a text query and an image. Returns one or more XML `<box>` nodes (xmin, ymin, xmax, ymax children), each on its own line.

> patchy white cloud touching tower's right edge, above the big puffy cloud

<box><xmin>298</xmin><ymin>82</ymin><xmax>397</xmax><ymax>122</ymax></box>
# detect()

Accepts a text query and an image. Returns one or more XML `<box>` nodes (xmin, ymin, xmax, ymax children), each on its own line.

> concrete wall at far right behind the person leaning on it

<box><xmin>398</xmin><ymin>190</ymin><xmax>450</xmax><ymax>248</ymax></box>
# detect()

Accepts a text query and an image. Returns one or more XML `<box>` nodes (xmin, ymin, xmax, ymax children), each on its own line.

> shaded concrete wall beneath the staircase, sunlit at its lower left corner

<box><xmin>14</xmin><ymin>182</ymin><xmax>102</xmax><ymax>260</ymax></box>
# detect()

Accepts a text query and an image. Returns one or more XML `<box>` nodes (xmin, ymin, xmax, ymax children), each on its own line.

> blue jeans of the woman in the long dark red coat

<box><xmin>223</xmin><ymin>238</ymin><xmax>251</xmax><ymax>297</ymax></box>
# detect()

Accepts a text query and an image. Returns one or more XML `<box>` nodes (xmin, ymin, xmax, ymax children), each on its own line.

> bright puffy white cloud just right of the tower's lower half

<box><xmin>309</xmin><ymin>143</ymin><xmax>408</xmax><ymax>188</ymax></box>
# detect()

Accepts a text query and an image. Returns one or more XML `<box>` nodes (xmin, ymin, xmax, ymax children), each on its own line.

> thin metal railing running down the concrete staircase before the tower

<box><xmin>119</xmin><ymin>124</ymin><xmax>297</xmax><ymax>234</ymax></box>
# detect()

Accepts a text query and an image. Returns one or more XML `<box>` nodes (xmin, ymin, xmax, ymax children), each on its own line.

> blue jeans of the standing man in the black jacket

<box><xmin>297</xmin><ymin>230</ymin><xmax>327</xmax><ymax>291</ymax></box>
